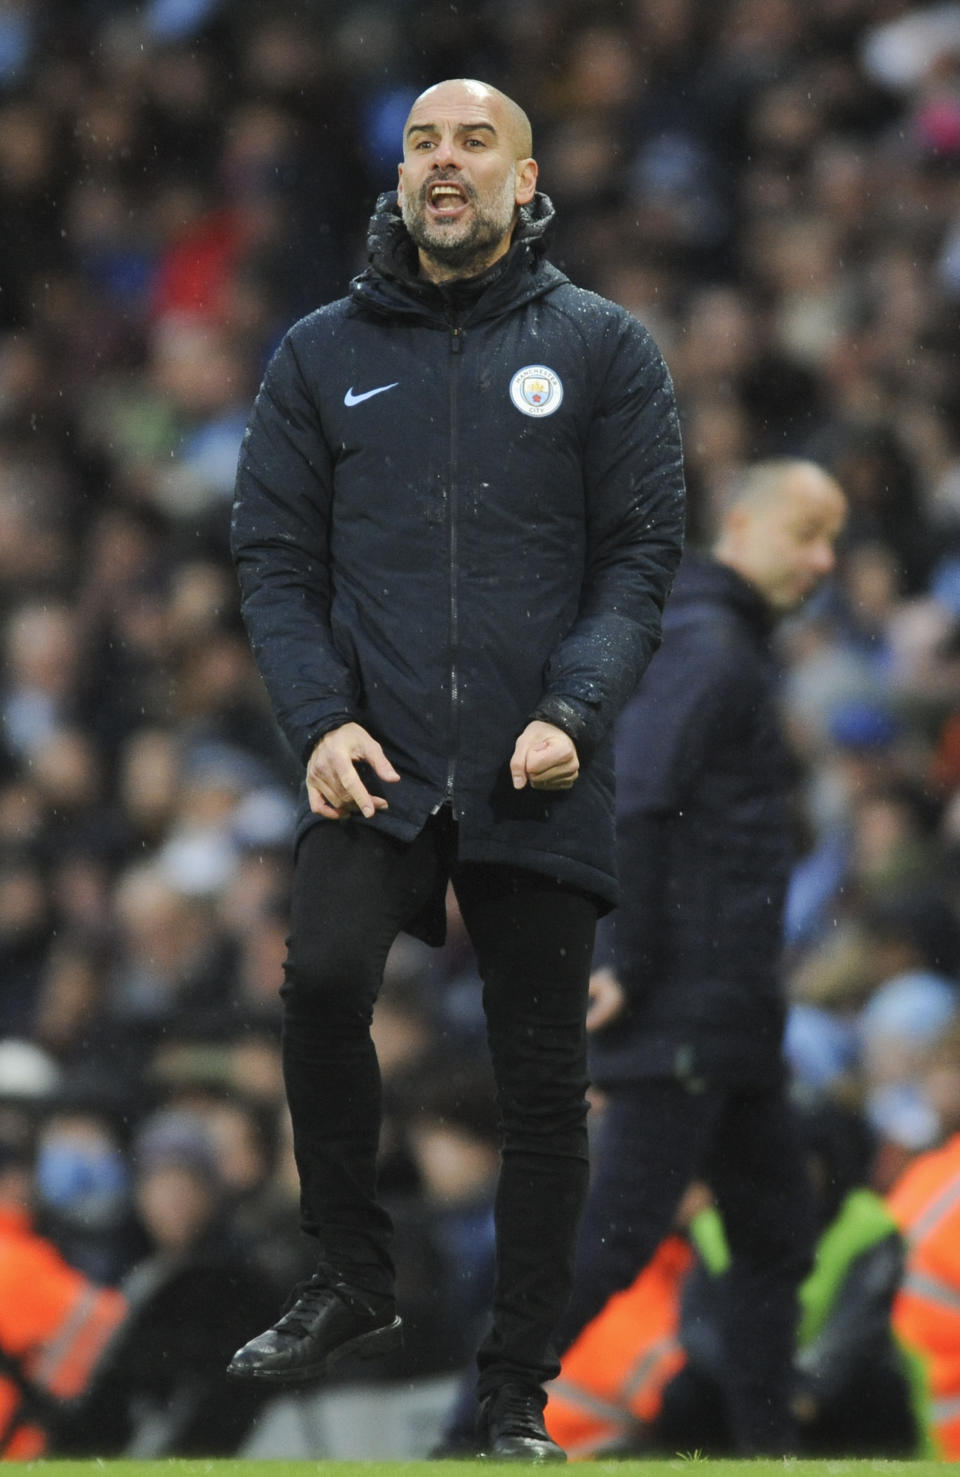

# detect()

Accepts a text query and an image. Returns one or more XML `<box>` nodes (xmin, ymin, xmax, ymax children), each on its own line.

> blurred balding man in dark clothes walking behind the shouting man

<box><xmin>561</xmin><ymin>459</ymin><xmax>846</xmax><ymax>1455</ymax></box>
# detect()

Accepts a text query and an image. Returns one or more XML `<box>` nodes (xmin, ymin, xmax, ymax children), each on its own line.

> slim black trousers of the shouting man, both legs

<box><xmin>281</xmin><ymin>814</ymin><xmax>597</xmax><ymax>1396</ymax></box>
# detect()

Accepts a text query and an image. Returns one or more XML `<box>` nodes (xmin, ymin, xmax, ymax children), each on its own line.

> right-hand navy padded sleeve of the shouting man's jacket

<box><xmin>533</xmin><ymin>313</ymin><xmax>684</xmax><ymax>755</ymax></box>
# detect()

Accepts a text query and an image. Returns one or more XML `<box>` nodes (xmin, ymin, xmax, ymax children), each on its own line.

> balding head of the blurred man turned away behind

<box><xmin>713</xmin><ymin>459</ymin><xmax>846</xmax><ymax>614</ymax></box>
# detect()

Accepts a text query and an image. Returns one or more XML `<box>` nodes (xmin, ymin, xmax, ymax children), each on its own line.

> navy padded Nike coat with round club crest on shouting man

<box><xmin>232</xmin><ymin>196</ymin><xmax>684</xmax><ymax>901</ymax></box>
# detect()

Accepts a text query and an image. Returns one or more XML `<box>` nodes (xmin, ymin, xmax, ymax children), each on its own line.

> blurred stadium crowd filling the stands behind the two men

<box><xmin>0</xmin><ymin>0</ymin><xmax>960</xmax><ymax>1449</ymax></box>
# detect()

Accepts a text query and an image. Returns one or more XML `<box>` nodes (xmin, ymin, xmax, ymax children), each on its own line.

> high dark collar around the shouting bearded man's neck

<box><xmin>350</xmin><ymin>191</ymin><xmax>566</xmax><ymax>322</ymax></box>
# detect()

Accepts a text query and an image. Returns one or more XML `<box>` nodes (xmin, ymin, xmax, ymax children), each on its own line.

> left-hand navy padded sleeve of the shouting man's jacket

<box><xmin>230</xmin><ymin>329</ymin><xmax>356</xmax><ymax>762</ymax></box>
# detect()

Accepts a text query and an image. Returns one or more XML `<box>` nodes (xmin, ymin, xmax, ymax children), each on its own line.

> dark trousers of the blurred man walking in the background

<box><xmin>558</xmin><ymin>1078</ymin><xmax>814</xmax><ymax>1455</ymax></box>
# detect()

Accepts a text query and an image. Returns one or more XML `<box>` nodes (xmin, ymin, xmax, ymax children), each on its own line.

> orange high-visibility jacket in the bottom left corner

<box><xmin>0</xmin><ymin>1208</ymin><xmax>127</xmax><ymax>1461</ymax></box>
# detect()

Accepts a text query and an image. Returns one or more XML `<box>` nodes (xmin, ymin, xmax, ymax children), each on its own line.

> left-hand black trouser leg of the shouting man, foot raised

<box><xmin>281</xmin><ymin>821</ymin><xmax>443</xmax><ymax>1294</ymax></box>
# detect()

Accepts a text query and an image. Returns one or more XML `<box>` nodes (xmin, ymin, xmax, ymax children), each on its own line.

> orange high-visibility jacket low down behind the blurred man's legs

<box><xmin>545</xmin><ymin>1236</ymin><xmax>694</xmax><ymax>1459</ymax></box>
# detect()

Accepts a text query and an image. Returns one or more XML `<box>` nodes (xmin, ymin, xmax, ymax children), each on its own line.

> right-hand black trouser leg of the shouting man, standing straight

<box><xmin>453</xmin><ymin>866</ymin><xmax>597</xmax><ymax>1397</ymax></box>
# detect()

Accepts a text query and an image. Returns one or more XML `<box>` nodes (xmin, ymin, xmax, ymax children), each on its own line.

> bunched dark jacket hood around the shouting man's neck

<box><xmin>350</xmin><ymin>191</ymin><xmax>566</xmax><ymax>319</ymax></box>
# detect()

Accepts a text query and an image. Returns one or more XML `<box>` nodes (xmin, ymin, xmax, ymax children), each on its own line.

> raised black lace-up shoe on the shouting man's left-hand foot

<box><xmin>226</xmin><ymin>1276</ymin><xmax>403</xmax><ymax>1384</ymax></box>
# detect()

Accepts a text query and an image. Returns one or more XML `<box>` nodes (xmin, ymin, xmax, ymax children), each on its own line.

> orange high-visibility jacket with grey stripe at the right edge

<box><xmin>888</xmin><ymin>1134</ymin><xmax>960</xmax><ymax>1461</ymax></box>
